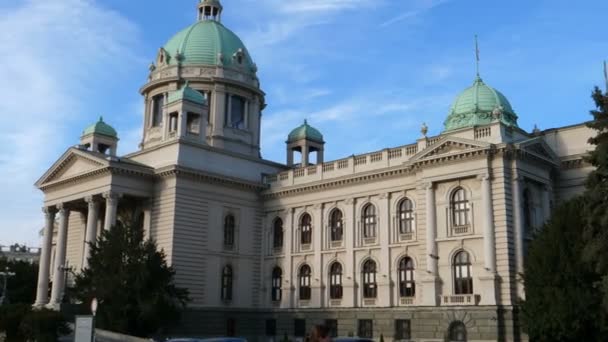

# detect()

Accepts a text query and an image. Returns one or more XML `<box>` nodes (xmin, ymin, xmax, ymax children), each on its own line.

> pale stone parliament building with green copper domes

<box><xmin>29</xmin><ymin>0</ymin><xmax>594</xmax><ymax>342</ymax></box>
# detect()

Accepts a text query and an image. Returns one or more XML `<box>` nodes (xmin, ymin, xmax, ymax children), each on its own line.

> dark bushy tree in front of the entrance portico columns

<box><xmin>74</xmin><ymin>216</ymin><xmax>189</xmax><ymax>336</ymax></box>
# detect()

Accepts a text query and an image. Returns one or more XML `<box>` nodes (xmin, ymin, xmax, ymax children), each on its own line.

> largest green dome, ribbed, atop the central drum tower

<box><xmin>163</xmin><ymin>20</ymin><xmax>256</xmax><ymax>73</ymax></box>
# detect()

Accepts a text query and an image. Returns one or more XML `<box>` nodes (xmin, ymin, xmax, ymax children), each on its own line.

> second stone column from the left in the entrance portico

<box><xmin>49</xmin><ymin>204</ymin><xmax>70</xmax><ymax>309</ymax></box>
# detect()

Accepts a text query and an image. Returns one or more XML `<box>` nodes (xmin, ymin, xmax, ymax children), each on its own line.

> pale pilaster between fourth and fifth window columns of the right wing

<box><xmin>378</xmin><ymin>193</ymin><xmax>393</xmax><ymax>307</ymax></box>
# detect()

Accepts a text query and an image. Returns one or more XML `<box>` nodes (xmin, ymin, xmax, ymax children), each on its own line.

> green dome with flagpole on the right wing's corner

<box><xmin>444</xmin><ymin>76</ymin><xmax>517</xmax><ymax>131</ymax></box>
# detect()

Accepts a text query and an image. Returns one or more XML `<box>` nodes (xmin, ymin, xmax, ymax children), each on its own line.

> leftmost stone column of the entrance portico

<box><xmin>34</xmin><ymin>207</ymin><xmax>57</xmax><ymax>307</ymax></box>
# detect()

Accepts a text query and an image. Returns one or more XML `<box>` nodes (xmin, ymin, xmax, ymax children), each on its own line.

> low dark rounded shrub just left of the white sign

<box><xmin>20</xmin><ymin>309</ymin><xmax>70</xmax><ymax>342</ymax></box>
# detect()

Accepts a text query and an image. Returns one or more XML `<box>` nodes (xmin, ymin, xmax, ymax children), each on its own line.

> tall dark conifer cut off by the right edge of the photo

<box><xmin>584</xmin><ymin>87</ymin><xmax>608</xmax><ymax>313</ymax></box>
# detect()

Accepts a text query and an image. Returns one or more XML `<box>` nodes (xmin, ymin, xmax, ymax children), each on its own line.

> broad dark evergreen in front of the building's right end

<box><xmin>521</xmin><ymin>198</ymin><xmax>608</xmax><ymax>342</ymax></box>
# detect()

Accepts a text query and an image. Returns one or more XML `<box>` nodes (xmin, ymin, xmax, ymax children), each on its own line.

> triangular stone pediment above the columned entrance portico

<box><xmin>36</xmin><ymin>148</ymin><xmax>109</xmax><ymax>187</ymax></box>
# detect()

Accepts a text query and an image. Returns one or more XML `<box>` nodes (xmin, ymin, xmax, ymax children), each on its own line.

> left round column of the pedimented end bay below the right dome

<box><xmin>422</xmin><ymin>183</ymin><xmax>439</xmax><ymax>306</ymax></box>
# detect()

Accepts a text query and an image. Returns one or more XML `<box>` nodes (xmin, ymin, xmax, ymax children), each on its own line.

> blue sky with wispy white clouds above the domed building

<box><xmin>0</xmin><ymin>0</ymin><xmax>608</xmax><ymax>245</ymax></box>
